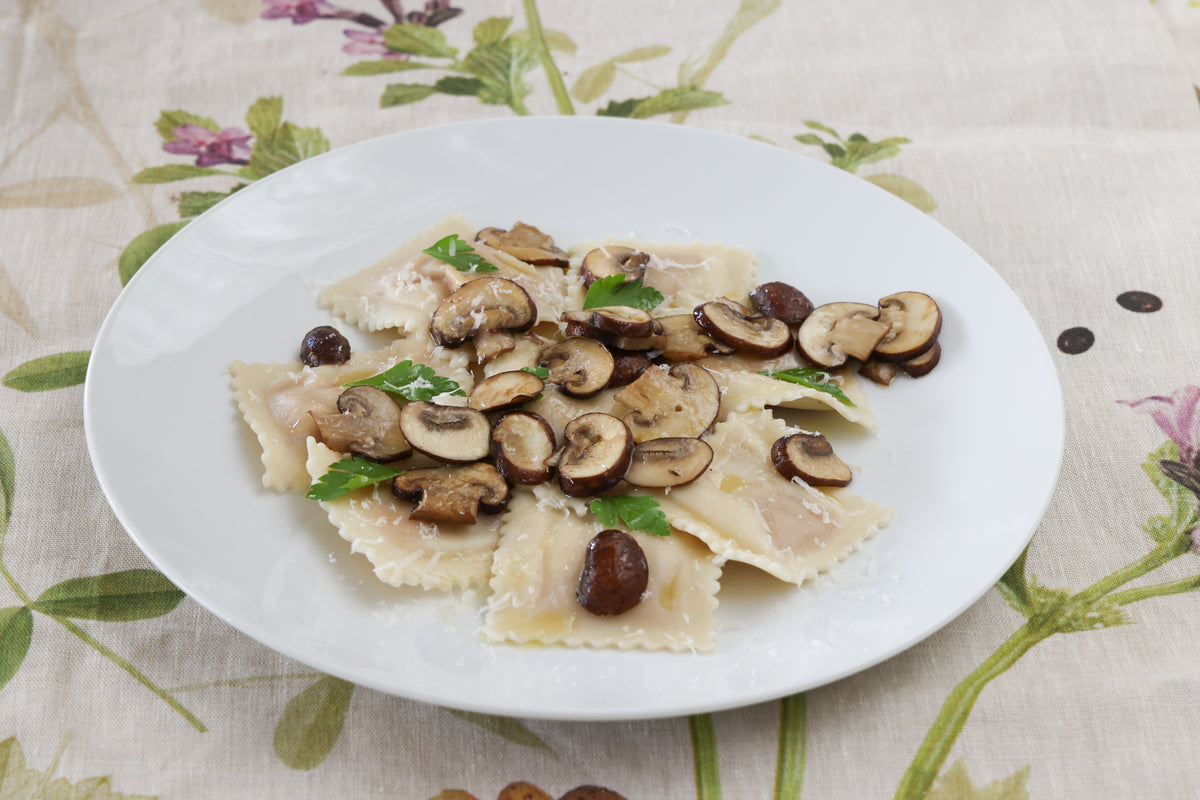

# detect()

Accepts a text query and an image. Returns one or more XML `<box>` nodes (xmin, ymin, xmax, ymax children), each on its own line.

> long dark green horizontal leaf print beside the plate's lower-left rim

<box><xmin>32</xmin><ymin>570</ymin><xmax>184</xmax><ymax>622</ymax></box>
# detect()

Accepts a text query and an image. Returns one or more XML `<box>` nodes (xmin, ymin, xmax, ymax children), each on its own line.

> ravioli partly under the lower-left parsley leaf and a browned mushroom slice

<box><xmin>306</xmin><ymin>439</ymin><xmax>500</xmax><ymax>590</ymax></box>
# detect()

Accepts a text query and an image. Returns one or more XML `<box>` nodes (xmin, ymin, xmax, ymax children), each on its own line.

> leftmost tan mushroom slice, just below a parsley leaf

<box><xmin>312</xmin><ymin>386</ymin><xmax>413</xmax><ymax>462</ymax></box>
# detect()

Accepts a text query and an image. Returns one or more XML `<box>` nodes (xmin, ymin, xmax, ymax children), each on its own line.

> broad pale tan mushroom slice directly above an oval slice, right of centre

<box><xmin>613</xmin><ymin>363</ymin><xmax>721</xmax><ymax>443</ymax></box>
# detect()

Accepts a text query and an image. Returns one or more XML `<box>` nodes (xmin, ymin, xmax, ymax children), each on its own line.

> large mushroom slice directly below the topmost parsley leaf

<box><xmin>430</xmin><ymin>276</ymin><xmax>538</xmax><ymax>348</ymax></box>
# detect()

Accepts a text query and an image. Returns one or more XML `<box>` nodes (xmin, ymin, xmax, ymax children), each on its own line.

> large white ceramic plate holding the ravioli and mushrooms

<box><xmin>85</xmin><ymin>118</ymin><xmax>1063</xmax><ymax>720</ymax></box>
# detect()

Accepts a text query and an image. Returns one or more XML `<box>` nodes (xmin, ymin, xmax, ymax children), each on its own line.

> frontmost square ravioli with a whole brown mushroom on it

<box><xmin>484</xmin><ymin>487</ymin><xmax>721</xmax><ymax>651</ymax></box>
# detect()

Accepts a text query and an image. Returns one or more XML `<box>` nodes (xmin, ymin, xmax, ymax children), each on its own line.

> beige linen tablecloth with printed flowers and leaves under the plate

<box><xmin>0</xmin><ymin>0</ymin><xmax>1200</xmax><ymax>800</ymax></box>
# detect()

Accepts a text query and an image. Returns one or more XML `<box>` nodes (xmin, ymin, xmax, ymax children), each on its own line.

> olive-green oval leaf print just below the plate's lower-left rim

<box><xmin>275</xmin><ymin>675</ymin><xmax>354</xmax><ymax>771</ymax></box>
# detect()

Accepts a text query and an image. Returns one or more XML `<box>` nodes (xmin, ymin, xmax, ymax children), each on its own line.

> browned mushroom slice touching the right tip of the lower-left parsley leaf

<box><xmin>391</xmin><ymin>463</ymin><xmax>512</xmax><ymax>525</ymax></box>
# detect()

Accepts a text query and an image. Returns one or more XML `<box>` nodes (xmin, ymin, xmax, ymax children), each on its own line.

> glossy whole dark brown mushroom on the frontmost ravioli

<box><xmin>575</xmin><ymin>528</ymin><xmax>650</xmax><ymax>616</ymax></box>
